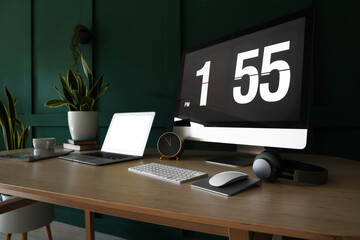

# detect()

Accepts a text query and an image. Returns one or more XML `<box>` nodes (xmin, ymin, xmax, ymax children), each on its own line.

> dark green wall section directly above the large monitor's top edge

<box><xmin>181</xmin><ymin>0</ymin><xmax>312</xmax><ymax>49</ymax></box>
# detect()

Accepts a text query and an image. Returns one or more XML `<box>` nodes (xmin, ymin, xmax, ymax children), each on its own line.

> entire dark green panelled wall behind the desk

<box><xmin>0</xmin><ymin>0</ymin><xmax>360</xmax><ymax>239</ymax></box>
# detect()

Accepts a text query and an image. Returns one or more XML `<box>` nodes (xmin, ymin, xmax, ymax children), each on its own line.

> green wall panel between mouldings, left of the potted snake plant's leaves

<box><xmin>32</xmin><ymin>0</ymin><xmax>92</xmax><ymax>114</ymax></box>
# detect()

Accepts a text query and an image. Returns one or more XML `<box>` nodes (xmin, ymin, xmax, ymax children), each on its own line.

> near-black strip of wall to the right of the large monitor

<box><xmin>310</xmin><ymin>0</ymin><xmax>360</xmax><ymax>160</ymax></box>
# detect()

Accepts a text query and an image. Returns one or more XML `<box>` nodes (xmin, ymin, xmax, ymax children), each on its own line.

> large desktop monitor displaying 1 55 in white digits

<box><xmin>174</xmin><ymin>9</ymin><xmax>314</xmax><ymax>165</ymax></box>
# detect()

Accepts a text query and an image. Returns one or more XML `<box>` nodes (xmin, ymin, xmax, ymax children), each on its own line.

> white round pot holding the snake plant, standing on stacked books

<box><xmin>68</xmin><ymin>111</ymin><xmax>99</xmax><ymax>140</ymax></box>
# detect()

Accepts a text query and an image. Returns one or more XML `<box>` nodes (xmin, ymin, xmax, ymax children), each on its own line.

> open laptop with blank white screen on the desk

<box><xmin>60</xmin><ymin>112</ymin><xmax>155</xmax><ymax>165</ymax></box>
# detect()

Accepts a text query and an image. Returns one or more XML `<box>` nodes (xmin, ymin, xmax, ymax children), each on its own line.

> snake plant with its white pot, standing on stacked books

<box><xmin>45</xmin><ymin>55</ymin><xmax>109</xmax><ymax>140</ymax></box>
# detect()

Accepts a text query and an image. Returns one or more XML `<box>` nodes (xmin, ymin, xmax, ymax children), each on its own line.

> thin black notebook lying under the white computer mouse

<box><xmin>191</xmin><ymin>177</ymin><xmax>261</xmax><ymax>197</ymax></box>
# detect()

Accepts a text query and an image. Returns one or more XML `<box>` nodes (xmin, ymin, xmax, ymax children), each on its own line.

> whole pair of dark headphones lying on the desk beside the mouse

<box><xmin>253</xmin><ymin>149</ymin><xmax>328</xmax><ymax>184</ymax></box>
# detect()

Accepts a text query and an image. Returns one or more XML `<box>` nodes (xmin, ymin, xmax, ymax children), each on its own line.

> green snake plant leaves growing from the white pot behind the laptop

<box><xmin>45</xmin><ymin>55</ymin><xmax>109</xmax><ymax>111</ymax></box>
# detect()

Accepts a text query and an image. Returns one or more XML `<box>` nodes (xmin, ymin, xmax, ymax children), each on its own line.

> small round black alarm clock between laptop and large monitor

<box><xmin>157</xmin><ymin>132</ymin><xmax>184</xmax><ymax>160</ymax></box>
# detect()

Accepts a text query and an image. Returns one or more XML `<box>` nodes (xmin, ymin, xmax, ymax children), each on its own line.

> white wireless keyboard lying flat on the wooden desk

<box><xmin>128</xmin><ymin>163</ymin><xmax>207</xmax><ymax>183</ymax></box>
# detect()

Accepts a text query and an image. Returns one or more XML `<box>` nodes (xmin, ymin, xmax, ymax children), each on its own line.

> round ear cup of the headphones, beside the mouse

<box><xmin>253</xmin><ymin>150</ymin><xmax>282</xmax><ymax>182</ymax></box>
